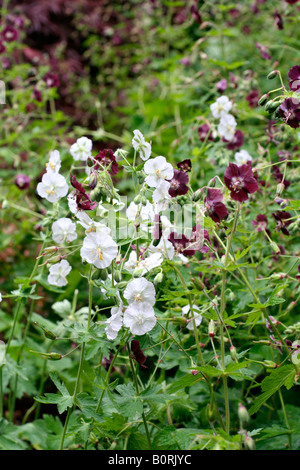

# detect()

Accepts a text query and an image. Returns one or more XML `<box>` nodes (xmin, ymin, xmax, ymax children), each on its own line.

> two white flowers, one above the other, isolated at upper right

<box><xmin>210</xmin><ymin>95</ymin><xmax>237</xmax><ymax>141</ymax></box>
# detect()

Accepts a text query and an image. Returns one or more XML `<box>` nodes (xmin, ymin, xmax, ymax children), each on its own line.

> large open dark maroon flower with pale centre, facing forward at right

<box><xmin>224</xmin><ymin>163</ymin><xmax>258</xmax><ymax>202</ymax></box>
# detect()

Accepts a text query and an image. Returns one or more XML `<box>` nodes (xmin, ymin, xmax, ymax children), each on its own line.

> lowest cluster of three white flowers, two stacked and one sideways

<box><xmin>105</xmin><ymin>277</ymin><xmax>156</xmax><ymax>339</ymax></box>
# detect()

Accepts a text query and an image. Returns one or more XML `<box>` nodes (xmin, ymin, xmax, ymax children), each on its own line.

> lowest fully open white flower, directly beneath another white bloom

<box><xmin>124</xmin><ymin>302</ymin><xmax>156</xmax><ymax>335</ymax></box>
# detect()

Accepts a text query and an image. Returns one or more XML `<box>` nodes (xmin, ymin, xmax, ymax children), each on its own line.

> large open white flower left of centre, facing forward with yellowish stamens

<box><xmin>80</xmin><ymin>232</ymin><xmax>118</xmax><ymax>269</ymax></box>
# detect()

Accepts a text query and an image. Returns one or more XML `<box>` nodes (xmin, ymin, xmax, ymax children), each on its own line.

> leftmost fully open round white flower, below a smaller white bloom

<box><xmin>37</xmin><ymin>171</ymin><xmax>69</xmax><ymax>202</ymax></box>
